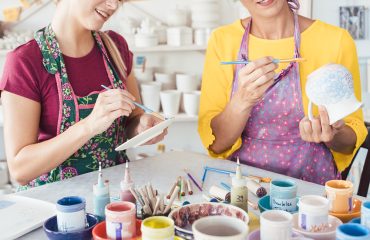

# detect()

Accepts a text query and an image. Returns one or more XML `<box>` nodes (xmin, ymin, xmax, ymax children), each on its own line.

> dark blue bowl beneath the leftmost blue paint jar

<box><xmin>44</xmin><ymin>213</ymin><xmax>99</xmax><ymax>240</ymax></box>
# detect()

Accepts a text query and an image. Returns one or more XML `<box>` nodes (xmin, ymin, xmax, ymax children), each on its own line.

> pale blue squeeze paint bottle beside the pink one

<box><xmin>93</xmin><ymin>162</ymin><xmax>110</xmax><ymax>220</ymax></box>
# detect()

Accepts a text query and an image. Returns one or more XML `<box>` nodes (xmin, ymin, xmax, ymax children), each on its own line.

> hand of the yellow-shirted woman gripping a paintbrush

<box><xmin>232</xmin><ymin>57</ymin><xmax>278</xmax><ymax>112</ymax></box>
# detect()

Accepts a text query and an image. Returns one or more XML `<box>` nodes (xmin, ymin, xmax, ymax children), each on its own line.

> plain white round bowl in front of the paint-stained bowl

<box><xmin>192</xmin><ymin>216</ymin><xmax>249</xmax><ymax>240</ymax></box>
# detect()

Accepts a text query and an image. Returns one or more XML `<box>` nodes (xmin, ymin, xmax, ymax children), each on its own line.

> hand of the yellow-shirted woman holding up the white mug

<box><xmin>299</xmin><ymin>106</ymin><xmax>345</xmax><ymax>143</ymax></box>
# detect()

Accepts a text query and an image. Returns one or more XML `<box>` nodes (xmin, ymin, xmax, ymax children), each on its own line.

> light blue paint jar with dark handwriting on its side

<box><xmin>270</xmin><ymin>179</ymin><xmax>297</xmax><ymax>212</ymax></box>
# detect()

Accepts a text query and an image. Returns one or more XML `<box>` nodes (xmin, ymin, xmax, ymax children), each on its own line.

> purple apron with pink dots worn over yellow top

<box><xmin>230</xmin><ymin>14</ymin><xmax>340</xmax><ymax>184</ymax></box>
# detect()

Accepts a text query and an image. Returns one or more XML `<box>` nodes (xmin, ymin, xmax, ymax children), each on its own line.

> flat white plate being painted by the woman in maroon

<box><xmin>116</xmin><ymin>118</ymin><xmax>174</xmax><ymax>151</ymax></box>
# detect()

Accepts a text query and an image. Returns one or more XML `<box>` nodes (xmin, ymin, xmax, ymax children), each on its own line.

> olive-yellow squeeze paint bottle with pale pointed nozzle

<box><xmin>231</xmin><ymin>158</ymin><xmax>248</xmax><ymax>212</ymax></box>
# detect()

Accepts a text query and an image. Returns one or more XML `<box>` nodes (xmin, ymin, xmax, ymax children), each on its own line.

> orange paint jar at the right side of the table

<box><xmin>325</xmin><ymin>180</ymin><xmax>353</xmax><ymax>213</ymax></box>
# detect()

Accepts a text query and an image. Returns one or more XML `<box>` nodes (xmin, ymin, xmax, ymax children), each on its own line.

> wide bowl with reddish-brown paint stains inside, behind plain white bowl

<box><xmin>168</xmin><ymin>203</ymin><xmax>249</xmax><ymax>239</ymax></box>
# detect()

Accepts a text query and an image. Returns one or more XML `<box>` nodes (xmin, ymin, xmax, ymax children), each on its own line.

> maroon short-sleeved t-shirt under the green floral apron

<box><xmin>0</xmin><ymin>31</ymin><xmax>133</xmax><ymax>141</ymax></box>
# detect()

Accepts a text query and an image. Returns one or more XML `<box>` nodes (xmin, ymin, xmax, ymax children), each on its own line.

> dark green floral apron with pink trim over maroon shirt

<box><xmin>22</xmin><ymin>25</ymin><xmax>127</xmax><ymax>188</ymax></box>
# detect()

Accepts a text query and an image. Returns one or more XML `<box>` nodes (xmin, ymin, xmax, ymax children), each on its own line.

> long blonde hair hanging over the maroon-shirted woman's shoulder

<box><xmin>100</xmin><ymin>32</ymin><xmax>127</xmax><ymax>80</ymax></box>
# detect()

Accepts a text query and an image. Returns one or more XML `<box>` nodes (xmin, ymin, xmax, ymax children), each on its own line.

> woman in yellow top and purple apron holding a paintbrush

<box><xmin>198</xmin><ymin>0</ymin><xmax>367</xmax><ymax>184</ymax></box>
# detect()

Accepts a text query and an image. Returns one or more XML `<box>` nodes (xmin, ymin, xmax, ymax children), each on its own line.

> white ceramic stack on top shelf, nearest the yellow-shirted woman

<box><xmin>191</xmin><ymin>0</ymin><xmax>221</xmax><ymax>29</ymax></box>
